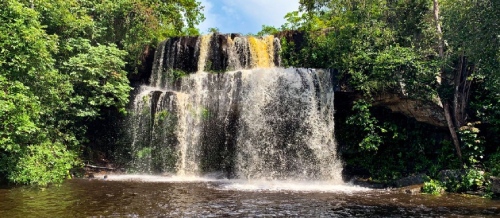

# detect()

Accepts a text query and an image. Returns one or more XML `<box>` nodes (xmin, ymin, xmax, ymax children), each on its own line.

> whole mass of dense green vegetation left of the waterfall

<box><xmin>0</xmin><ymin>0</ymin><xmax>204</xmax><ymax>185</ymax></box>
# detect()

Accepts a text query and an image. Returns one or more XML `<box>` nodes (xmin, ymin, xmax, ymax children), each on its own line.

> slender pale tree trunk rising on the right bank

<box><xmin>433</xmin><ymin>0</ymin><xmax>462</xmax><ymax>162</ymax></box>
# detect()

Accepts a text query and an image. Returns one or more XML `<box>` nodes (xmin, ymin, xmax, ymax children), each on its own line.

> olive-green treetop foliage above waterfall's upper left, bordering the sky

<box><xmin>88</xmin><ymin>0</ymin><xmax>204</xmax><ymax>69</ymax></box>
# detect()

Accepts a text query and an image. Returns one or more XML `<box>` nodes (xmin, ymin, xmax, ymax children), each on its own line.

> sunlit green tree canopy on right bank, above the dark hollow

<box><xmin>290</xmin><ymin>0</ymin><xmax>500</xmax><ymax>169</ymax></box>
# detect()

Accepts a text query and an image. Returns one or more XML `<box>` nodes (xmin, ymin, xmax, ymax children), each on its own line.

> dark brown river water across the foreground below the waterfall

<box><xmin>0</xmin><ymin>176</ymin><xmax>500</xmax><ymax>217</ymax></box>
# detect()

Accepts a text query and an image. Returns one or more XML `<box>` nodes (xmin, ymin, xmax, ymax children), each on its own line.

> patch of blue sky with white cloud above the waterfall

<box><xmin>198</xmin><ymin>0</ymin><xmax>299</xmax><ymax>34</ymax></box>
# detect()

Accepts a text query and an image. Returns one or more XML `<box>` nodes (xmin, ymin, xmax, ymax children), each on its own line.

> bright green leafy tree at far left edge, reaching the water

<box><xmin>0</xmin><ymin>0</ymin><xmax>77</xmax><ymax>185</ymax></box>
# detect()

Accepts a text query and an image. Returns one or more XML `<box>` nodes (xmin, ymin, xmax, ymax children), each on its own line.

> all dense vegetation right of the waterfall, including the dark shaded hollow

<box><xmin>266</xmin><ymin>0</ymin><xmax>500</xmax><ymax>194</ymax></box>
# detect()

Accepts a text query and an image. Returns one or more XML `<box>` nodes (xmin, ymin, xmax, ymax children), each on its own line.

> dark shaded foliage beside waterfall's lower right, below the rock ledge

<box><xmin>335</xmin><ymin>106</ymin><xmax>450</xmax><ymax>182</ymax></box>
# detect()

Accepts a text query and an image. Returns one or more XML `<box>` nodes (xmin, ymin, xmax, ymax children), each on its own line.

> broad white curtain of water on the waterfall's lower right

<box><xmin>237</xmin><ymin>68</ymin><xmax>341</xmax><ymax>181</ymax></box>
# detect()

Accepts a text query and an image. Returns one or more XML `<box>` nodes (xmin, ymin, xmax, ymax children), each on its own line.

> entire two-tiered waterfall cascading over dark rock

<box><xmin>130</xmin><ymin>32</ymin><xmax>341</xmax><ymax>183</ymax></box>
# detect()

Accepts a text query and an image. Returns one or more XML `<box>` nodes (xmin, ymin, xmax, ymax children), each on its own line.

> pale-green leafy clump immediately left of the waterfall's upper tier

<box><xmin>63</xmin><ymin>39</ymin><xmax>131</xmax><ymax>117</ymax></box>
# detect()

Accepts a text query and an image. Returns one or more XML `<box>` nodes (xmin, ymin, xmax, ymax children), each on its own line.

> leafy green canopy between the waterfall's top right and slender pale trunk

<box><xmin>282</xmin><ymin>0</ymin><xmax>439</xmax><ymax>101</ymax></box>
